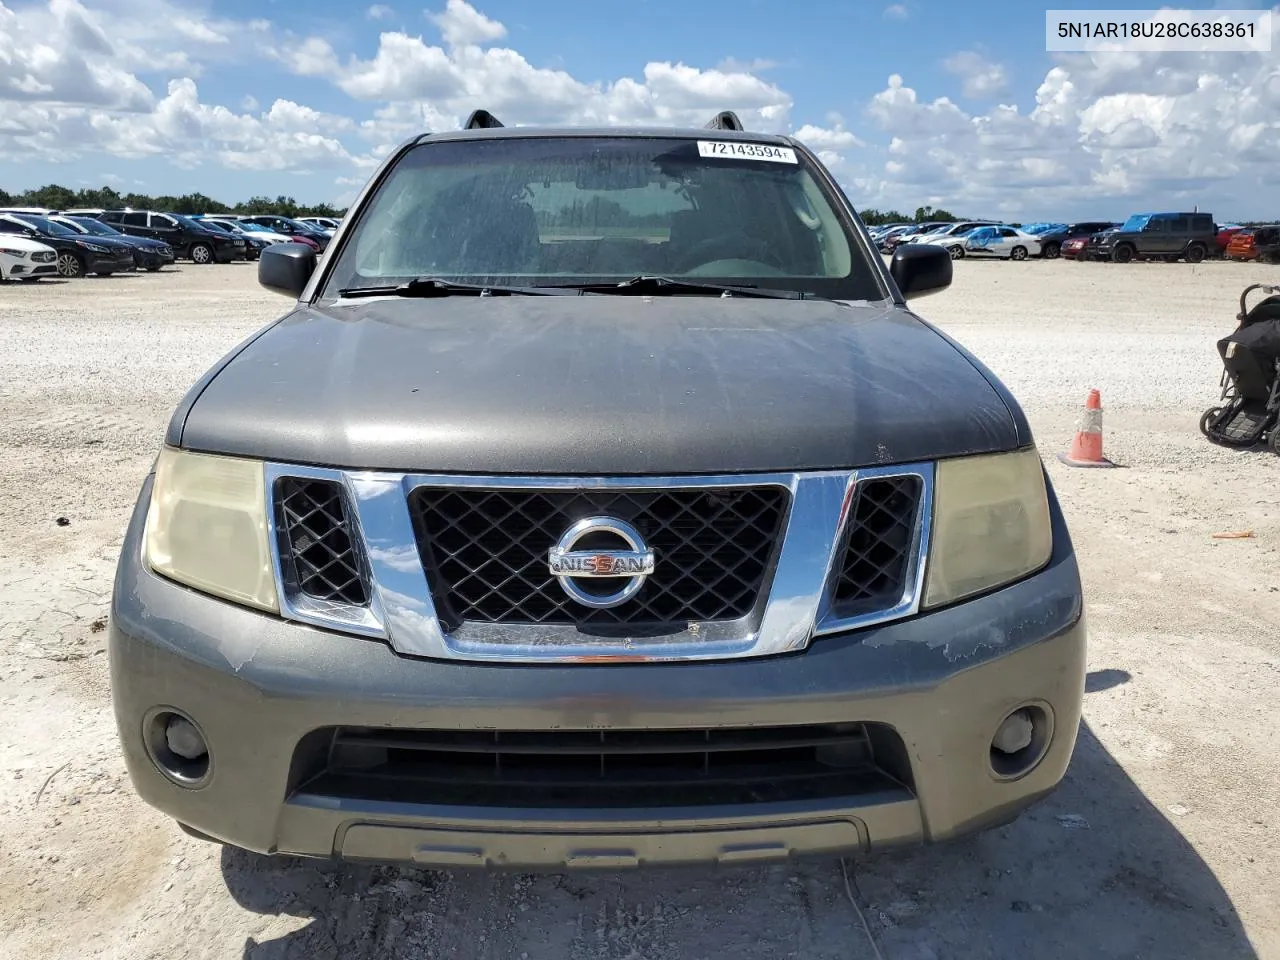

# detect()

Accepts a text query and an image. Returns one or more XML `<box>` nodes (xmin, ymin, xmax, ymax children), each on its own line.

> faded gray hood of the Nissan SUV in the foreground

<box><xmin>177</xmin><ymin>296</ymin><xmax>1020</xmax><ymax>475</ymax></box>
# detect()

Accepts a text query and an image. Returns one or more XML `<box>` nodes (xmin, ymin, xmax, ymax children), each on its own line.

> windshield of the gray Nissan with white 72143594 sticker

<box><xmin>324</xmin><ymin>137</ymin><xmax>886</xmax><ymax>300</ymax></box>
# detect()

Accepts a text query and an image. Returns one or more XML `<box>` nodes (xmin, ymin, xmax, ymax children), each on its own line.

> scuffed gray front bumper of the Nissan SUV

<box><xmin>109</xmin><ymin>477</ymin><xmax>1085</xmax><ymax>869</ymax></box>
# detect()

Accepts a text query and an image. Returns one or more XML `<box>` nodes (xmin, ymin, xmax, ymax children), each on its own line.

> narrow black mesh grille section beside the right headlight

<box><xmin>832</xmin><ymin>476</ymin><xmax>922</xmax><ymax>617</ymax></box>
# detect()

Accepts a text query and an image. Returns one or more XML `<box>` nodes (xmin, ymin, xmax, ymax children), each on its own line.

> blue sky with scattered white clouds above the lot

<box><xmin>0</xmin><ymin>0</ymin><xmax>1280</xmax><ymax>220</ymax></box>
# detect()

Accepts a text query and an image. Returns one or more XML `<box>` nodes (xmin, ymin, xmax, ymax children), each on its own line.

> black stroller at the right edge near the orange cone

<box><xmin>1201</xmin><ymin>283</ymin><xmax>1280</xmax><ymax>454</ymax></box>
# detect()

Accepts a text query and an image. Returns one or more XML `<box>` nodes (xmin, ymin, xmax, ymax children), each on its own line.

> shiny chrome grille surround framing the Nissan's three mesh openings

<box><xmin>266</xmin><ymin>463</ymin><xmax>933</xmax><ymax>663</ymax></box>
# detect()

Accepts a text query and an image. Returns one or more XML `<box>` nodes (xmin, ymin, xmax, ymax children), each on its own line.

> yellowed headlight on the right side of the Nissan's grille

<box><xmin>924</xmin><ymin>447</ymin><xmax>1053</xmax><ymax>608</ymax></box>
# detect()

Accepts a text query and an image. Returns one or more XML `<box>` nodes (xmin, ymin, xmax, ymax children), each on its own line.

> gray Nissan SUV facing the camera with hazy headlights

<box><xmin>110</xmin><ymin>111</ymin><xmax>1085</xmax><ymax>869</ymax></box>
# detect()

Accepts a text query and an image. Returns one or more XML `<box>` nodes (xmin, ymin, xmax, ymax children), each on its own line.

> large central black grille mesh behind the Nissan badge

<box><xmin>410</xmin><ymin>486</ymin><xmax>790</xmax><ymax>628</ymax></box>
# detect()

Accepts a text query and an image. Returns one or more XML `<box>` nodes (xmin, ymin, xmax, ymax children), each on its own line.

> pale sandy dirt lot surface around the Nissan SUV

<box><xmin>0</xmin><ymin>261</ymin><xmax>1280</xmax><ymax>960</ymax></box>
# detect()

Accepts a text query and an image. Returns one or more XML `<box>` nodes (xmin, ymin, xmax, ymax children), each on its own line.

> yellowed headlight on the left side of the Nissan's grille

<box><xmin>143</xmin><ymin>447</ymin><xmax>279</xmax><ymax>612</ymax></box>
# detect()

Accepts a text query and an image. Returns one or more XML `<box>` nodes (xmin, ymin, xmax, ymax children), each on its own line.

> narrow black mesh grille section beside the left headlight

<box><xmin>276</xmin><ymin>476</ymin><xmax>369</xmax><ymax>607</ymax></box>
